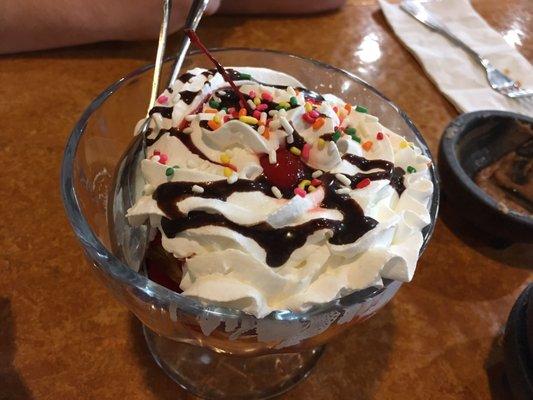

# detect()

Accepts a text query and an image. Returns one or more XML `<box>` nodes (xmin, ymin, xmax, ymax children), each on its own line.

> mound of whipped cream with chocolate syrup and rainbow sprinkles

<box><xmin>127</xmin><ymin>68</ymin><xmax>433</xmax><ymax>317</ymax></box>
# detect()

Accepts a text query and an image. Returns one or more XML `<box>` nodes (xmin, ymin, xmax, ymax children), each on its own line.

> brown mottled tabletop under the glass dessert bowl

<box><xmin>0</xmin><ymin>0</ymin><xmax>533</xmax><ymax>400</ymax></box>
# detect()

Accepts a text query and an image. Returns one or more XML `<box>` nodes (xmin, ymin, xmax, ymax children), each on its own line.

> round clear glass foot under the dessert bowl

<box><xmin>143</xmin><ymin>325</ymin><xmax>324</xmax><ymax>400</ymax></box>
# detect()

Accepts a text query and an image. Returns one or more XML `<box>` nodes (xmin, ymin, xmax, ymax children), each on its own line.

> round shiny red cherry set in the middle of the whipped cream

<box><xmin>259</xmin><ymin>148</ymin><xmax>305</xmax><ymax>189</ymax></box>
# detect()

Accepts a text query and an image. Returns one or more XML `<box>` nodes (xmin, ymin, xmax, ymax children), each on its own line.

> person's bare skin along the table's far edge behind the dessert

<box><xmin>0</xmin><ymin>0</ymin><xmax>345</xmax><ymax>54</ymax></box>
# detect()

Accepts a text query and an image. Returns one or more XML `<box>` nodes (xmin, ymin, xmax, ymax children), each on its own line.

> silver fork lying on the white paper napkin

<box><xmin>400</xmin><ymin>0</ymin><xmax>533</xmax><ymax>99</ymax></box>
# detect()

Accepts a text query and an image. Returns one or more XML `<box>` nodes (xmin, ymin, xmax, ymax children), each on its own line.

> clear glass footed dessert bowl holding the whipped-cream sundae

<box><xmin>62</xmin><ymin>49</ymin><xmax>439</xmax><ymax>399</ymax></box>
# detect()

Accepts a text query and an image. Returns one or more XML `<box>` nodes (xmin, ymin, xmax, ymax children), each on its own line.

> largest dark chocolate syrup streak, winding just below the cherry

<box><xmin>154</xmin><ymin>174</ymin><xmax>377</xmax><ymax>268</ymax></box>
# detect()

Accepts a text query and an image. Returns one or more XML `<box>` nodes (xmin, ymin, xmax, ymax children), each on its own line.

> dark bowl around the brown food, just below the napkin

<box><xmin>439</xmin><ymin>111</ymin><xmax>533</xmax><ymax>243</ymax></box>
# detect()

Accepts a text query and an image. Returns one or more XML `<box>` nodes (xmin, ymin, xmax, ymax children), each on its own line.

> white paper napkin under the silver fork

<box><xmin>378</xmin><ymin>0</ymin><xmax>533</xmax><ymax>116</ymax></box>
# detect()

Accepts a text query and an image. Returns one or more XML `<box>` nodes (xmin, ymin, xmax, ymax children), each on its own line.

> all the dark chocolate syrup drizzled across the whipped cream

<box><xmin>147</xmin><ymin>69</ymin><xmax>405</xmax><ymax>268</ymax></box>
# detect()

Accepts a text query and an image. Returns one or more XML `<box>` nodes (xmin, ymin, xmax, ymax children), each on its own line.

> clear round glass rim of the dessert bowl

<box><xmin>60</xmin><ymin>47</ymin><xmax>440</xmax><ymax>320</ymax></box>
